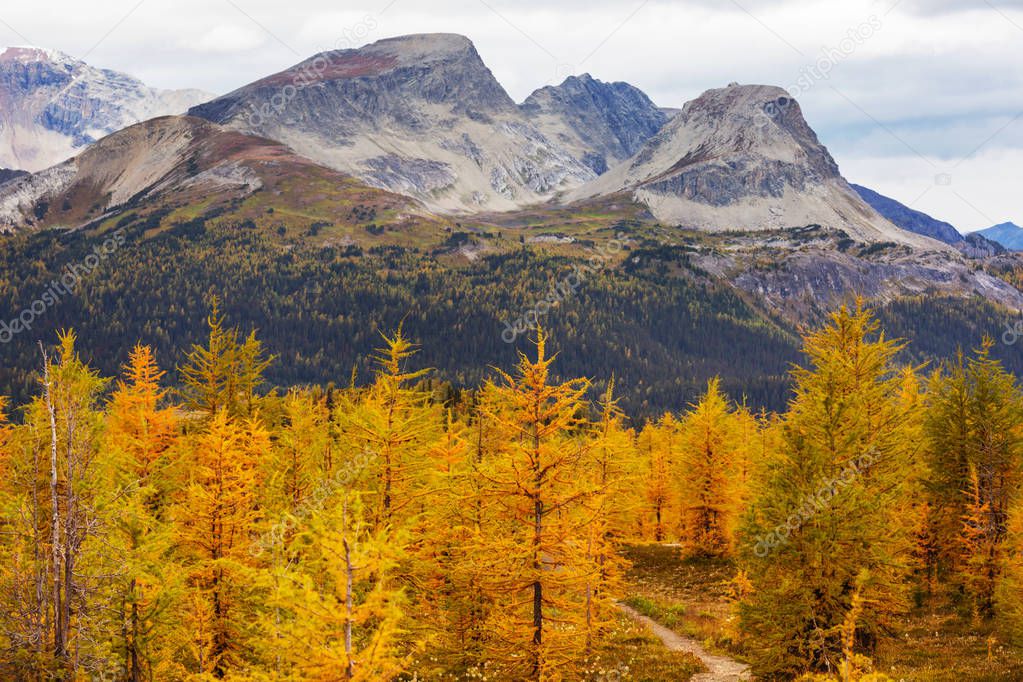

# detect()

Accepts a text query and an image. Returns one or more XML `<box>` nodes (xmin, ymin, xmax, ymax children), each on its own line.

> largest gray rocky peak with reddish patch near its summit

<box><xmin>190</xmin><ymin>34</ymin><xmax>594</xmax><ymax>213</ymax></box>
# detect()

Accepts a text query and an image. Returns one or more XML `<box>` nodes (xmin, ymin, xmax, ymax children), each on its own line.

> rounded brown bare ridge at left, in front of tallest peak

<box><xmin>0</xmin><ymin>117</ymin><xmax>426</xmax><ymax>233</ymax></box>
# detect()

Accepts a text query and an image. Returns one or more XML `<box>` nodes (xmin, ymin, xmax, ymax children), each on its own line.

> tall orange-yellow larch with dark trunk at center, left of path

<box><xmin>482</xmin><ymin>330</ymin><xmax>596</xmax><ymax>680</ymax></box>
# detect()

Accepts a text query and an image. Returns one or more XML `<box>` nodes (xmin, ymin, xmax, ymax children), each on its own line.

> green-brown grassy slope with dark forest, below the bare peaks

<box><xmin>0</xmin><ymin>189</ymin><xmax>1023</xmax><ymax>418</ymax></box>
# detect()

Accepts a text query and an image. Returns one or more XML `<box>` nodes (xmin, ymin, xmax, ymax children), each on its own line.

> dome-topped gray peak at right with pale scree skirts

<box><xmin>568</xmin><ymin>85</ymin><xmax>943</xmax><ymax>249</ymax></box>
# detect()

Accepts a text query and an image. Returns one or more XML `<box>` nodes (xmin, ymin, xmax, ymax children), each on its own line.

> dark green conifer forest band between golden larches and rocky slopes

<box><xmin>0</xmin><ymin>219</ymin><xmax>1023</xmax><ymax>418</ymax></box>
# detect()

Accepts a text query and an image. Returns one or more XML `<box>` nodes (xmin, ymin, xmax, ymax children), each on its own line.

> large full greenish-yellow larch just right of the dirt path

<box><xmin>740</xmin><ymin>304</ymin><xmax>920</xmax><ymax>675</ymax></box>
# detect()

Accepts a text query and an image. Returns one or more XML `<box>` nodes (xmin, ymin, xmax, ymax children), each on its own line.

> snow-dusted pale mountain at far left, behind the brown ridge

<box><xmin>0</xmin><ymin>47</ymin><xmax>210</xmax><ymax>171</ymax></box>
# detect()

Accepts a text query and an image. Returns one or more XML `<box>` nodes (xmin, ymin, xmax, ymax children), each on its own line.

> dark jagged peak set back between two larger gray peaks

<box><xmin>521</xmin><ymin>74</ymin><xmax>669</xmax><ymax>175</ymax></box>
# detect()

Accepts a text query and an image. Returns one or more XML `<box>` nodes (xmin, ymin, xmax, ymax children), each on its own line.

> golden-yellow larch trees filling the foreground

<box><xmin>0</xmin><ymin>300</ymin><xmax>1023</xmax><ymax>682</ymax></box>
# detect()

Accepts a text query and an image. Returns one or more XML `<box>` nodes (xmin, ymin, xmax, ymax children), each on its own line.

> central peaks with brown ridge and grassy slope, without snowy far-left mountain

<box><xmin>0</xmin><ymin>34</ymin><xmax>1023</xmax><ymax>318</ymax></box>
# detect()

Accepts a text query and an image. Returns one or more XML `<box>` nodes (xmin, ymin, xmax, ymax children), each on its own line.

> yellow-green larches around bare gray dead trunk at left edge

<box><xmin>0</xmin><ymin>331</ymin><xmax>108</xmax><ymax>681</ymax></box>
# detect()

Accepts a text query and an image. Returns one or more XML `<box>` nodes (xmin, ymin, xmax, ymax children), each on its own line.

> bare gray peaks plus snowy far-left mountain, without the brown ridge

<box><xmin>0</xmin><ymin>34</ymin><xmax>1006</xmax><ymax>253</ymax></box>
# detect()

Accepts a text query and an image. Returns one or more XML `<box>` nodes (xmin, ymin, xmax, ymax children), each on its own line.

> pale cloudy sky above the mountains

<box><xmin>0</xmin><ymin>0</ymin><xmax>1023</xmax><ymax>230</ymax></box>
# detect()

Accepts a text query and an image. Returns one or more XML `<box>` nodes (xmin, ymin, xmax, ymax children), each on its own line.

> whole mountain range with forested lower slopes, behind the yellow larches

<box><xmin>0</xmin><ymin>34</ymin><xmax>1023</xmax><ymax>413</ymax></box>
